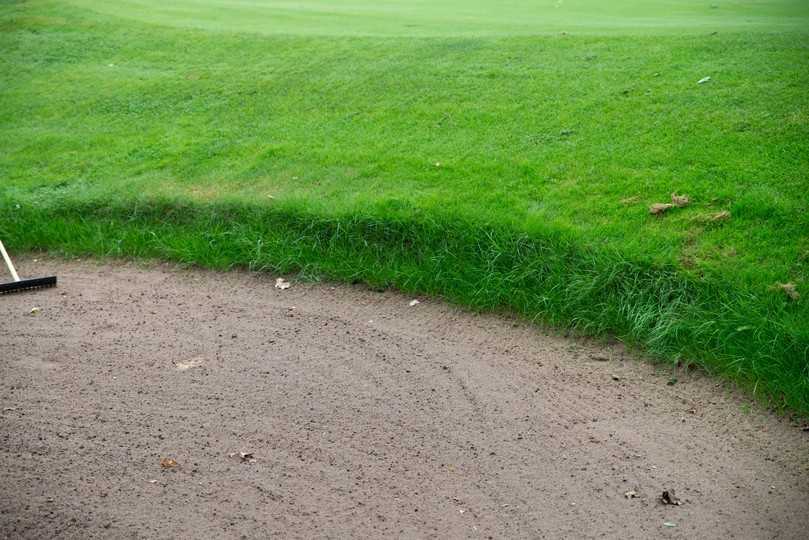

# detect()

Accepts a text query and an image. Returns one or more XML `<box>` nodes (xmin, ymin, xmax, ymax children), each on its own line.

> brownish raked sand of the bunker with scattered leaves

<box><xmin>0</xmin><ymin>258</ymin><xmax>809</xmax><ymax>539</ymax></box>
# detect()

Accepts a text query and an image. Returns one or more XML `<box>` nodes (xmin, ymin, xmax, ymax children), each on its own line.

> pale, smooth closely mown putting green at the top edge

<box><xmin>64</xmin><ymin>0</ymin><xmax>807</xmax><ymax>37</ymax></box>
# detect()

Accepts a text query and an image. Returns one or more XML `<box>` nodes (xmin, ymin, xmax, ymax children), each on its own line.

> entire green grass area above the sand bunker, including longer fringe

<box><xmin>0</xmin><ymin>0</ymin><xmax>809</xmax><ymax>415</ymax></box>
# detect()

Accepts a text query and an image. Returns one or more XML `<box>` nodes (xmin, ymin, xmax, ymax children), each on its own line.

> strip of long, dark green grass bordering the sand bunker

<box><xmin>0</xmin><ymin>197</ymin><xmax>809</xmax><ymax>414</ymax></box>
